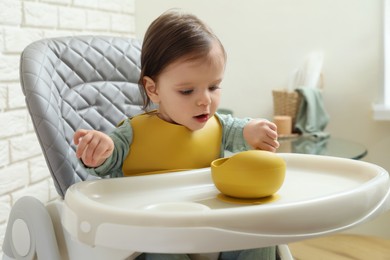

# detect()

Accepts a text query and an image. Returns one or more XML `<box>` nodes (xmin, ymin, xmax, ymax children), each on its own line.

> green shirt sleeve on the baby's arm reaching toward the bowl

<box><xmin>216</xmin><ymin>113</ymin><xmax>252</xmax><ymax>153</ymax></box>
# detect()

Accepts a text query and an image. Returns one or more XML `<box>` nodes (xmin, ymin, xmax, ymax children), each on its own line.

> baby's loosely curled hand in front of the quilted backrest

<box><xmin>73</xmin><ymin>129</ymin><xmax>114</xmax><ymax>168</ymax></box>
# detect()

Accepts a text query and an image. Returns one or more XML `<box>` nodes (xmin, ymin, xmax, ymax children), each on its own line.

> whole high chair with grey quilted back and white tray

<box><xmin>3</xmin><ymin>36</ymin><xmax>390</xmax><ymax>260</ymax></box>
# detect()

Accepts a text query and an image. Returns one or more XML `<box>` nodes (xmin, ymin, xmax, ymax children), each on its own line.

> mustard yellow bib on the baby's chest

<box><xmin>122</xmin><ymin>114</ymin><xmax>222</xmax><ymax>176</ymax></box>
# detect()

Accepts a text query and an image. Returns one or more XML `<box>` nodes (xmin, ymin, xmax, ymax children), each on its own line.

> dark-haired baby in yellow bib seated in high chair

<box><xmin>74</xmin><ymin>11</ymin><xmax>279</xmax><ymax>259</ymax></box>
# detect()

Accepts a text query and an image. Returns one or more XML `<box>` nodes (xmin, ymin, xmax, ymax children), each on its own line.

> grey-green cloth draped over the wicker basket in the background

<box><xmin>294</xmin><ymin>87</ymin><xmax>329</xmax><ymax>138</ymax></box>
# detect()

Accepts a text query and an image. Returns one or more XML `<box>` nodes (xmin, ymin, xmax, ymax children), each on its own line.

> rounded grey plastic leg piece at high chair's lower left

<box><xmin>3</xmin><ymin>196</ymin><xmax>61</xmax><ymax>260</ymax></box>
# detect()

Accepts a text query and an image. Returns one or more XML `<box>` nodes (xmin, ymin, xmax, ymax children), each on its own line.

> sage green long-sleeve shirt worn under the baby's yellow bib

<box><xmin>87</xmin><ymin>114</ymin><xmax>250</xmax><ymax>177</ymax></box>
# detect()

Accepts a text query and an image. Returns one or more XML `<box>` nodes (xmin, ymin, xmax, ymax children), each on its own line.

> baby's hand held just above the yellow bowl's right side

<box><xmin>243</xmin><ymin>119</ymin><xmax>279</xmax><ymax>152</ymax></box>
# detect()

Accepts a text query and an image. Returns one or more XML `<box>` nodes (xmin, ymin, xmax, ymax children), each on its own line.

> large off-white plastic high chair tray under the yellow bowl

<box><xmin>63</xmin><ymin>154</ymin><xmax>390</xmax><ymax>253</ymax></box>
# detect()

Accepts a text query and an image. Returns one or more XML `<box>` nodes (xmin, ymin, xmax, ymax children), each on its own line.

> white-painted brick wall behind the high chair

<box><xmin>0</xmin><ymin>0</ymin><xmax>135</xmax><ymax>259</ymax></box>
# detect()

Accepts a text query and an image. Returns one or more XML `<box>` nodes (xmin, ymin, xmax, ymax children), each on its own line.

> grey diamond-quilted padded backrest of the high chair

<box><xmin>20</xmin><ymin>36</ymin><xmax>143</xmax><ymax>197</ymax></box>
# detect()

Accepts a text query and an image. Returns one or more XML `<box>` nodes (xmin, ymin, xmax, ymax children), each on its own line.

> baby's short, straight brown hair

<box><xmin>138</xmin><ymin>10</ymin><xmax>226</xmax><ymax>109</ymax></box>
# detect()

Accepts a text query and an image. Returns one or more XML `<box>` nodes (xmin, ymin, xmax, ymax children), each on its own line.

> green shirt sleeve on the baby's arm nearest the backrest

<box><xmin>86</xmin><ymin>119</ymin><xmax>133</xmax><ymax>177</ymax></box>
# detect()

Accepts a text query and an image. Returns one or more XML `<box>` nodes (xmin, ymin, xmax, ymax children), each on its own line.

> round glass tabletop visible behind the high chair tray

<box><xmin>276</xmin><ymin>135</ymin><xmax>367</xmax><ymax>160</ymax></box>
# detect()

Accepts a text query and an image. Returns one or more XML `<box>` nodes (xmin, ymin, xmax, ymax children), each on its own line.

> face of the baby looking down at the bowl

<box><xmin>153</xmin><ymin>44</ymin><xmax>225</xmax><ymax>131</ymax></box>
